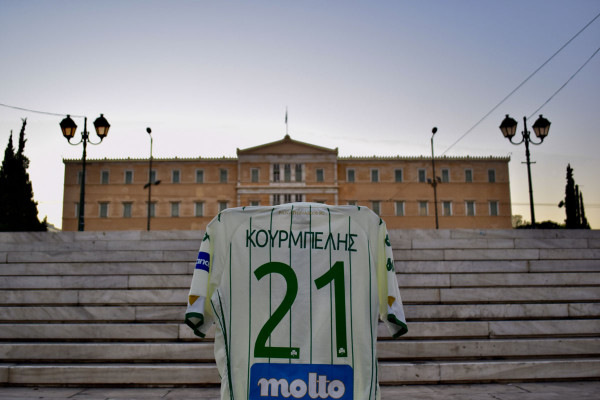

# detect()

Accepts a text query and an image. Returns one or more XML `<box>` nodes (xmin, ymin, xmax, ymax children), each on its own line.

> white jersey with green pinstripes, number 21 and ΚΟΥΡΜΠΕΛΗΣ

<box><xmin>186</xmin><ymin>203</ymin><xmax>407</xmax><ymax>400</ymax></box>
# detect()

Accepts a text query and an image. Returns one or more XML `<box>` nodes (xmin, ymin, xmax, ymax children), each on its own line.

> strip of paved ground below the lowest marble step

<box><xmin>0</xmin><ymin>381</ymin><xmax>600</xmax><ymax>400</ymax></box>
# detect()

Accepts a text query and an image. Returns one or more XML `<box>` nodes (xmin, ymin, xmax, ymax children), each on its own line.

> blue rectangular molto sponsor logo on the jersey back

<box><xmin>249</xmin><ymin>363</ymin><xmax>353</xmax><ymax>400</ymax></box>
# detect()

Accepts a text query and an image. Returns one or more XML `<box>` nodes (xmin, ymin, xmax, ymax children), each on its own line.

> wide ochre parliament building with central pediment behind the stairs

<box><xmin>62</xmin><ymin>135</ymin><xmax>511</xmax><ymax>231</ymax></box>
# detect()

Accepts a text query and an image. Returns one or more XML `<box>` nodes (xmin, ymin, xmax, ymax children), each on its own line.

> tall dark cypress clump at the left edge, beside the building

<box><xmin>0</xmin><ymin>119</ymin><xmax>47</xmax><ymax>231</ymax></box>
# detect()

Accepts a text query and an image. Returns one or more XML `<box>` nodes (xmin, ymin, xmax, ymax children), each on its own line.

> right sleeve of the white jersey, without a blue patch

<box><xmin>377</xmin><ymin>222</ymin><xmax>408</xmax><ymax>338</ymax></box>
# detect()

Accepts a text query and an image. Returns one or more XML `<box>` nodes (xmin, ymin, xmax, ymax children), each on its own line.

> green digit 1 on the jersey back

<box><xmin>315</xmin><ymin>261</ymin><xmax>348</xmax><ymax>357</ymax></box>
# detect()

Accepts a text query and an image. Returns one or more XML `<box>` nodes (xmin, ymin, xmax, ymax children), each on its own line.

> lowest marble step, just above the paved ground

<box><xmin>0</xmin><ymin>358</ymin><xmax>600</xmax><ymax>386</ymax></box>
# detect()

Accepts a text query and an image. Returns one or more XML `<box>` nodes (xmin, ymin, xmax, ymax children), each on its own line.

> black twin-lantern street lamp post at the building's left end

<box><xmin>60</xmin><ymin>114</ymin><xmax>110</xmax><ymax>231</ymax></box>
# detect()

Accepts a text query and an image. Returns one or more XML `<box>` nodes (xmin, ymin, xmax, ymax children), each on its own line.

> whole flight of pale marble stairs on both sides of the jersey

<box><xmin>0</xmin><ymin>230</ymin><xmax>600</xmax><ymax>386</ymax></box>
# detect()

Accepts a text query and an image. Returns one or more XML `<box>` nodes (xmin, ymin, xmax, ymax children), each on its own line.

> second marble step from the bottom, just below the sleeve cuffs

<box><xmin>0</xmin><ymin>338</ymin><xmax>600</xmax><ymax>363</ymax></box>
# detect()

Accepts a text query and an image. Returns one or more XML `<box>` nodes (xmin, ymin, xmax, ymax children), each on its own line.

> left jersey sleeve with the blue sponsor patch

<box><xmin>185</xmin><ymin>228</ymin><xmax>213</xmax><ymax>337</ymax></box>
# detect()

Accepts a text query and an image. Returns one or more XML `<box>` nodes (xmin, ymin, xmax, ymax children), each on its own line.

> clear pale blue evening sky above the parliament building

<box><xmin>0</xmin><ymin>0</ymin><xmax>600</xmax><ymax>228</ymax></box>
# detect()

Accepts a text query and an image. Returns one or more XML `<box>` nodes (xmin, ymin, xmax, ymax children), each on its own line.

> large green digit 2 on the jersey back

<box><xmin>254</xmin><ymin>262</ymin><xmax>300</xmax><ymax>358</ymax></box>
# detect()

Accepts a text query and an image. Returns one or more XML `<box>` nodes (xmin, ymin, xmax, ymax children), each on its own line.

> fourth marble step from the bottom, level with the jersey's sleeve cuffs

<box><xmin>0</xmin><ymin>303</ymin><xmax>600</xmax><ymax>322</ymax></box>
